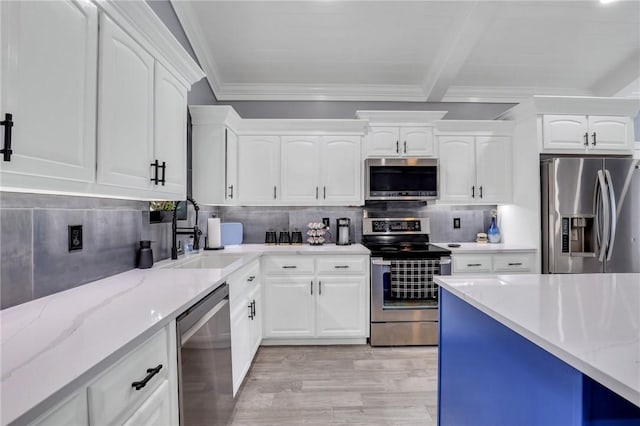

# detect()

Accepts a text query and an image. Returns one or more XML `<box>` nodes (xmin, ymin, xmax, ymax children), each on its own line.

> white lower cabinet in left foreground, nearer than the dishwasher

<box><xmin>31</xmin><ymin>322</ymin><xmax>178</xmax><ymax>426</ymax></box>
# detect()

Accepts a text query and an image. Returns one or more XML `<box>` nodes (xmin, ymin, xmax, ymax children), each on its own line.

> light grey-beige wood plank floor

<box><xmin>231</xmin><ymin>345</ymin><xmax>438</xmax><ymax>426</ymax></box>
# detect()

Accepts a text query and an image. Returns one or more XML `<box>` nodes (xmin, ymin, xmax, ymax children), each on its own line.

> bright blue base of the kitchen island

<box><xmin>438</xmin><ymin>289</ymin><xmax>640</xmax><ymax>426</ymax></box>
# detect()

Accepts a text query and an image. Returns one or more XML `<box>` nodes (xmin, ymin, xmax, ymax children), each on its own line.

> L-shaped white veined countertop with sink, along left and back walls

<box><xmin>0</xmin><ymin>244</ymin><xmax>369</xmax><ymax>425</ymax></box>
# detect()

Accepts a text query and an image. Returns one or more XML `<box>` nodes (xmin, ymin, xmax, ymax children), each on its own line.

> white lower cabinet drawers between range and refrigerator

<box><xmin>451</xmin><ymin>251</ymin><xmax>535</xmax><ymax>275</ymax></box>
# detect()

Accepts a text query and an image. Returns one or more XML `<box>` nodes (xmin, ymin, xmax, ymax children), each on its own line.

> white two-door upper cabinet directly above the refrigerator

<box><xmin>542</xmin><ymin>114</ymin><xmax>633</xmax><ymax>154</ymax></box>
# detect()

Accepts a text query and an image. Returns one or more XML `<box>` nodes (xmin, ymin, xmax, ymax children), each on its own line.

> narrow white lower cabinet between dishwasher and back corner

<box><xmin>227</xmin><ymin>260</ymin><xmax>262</xmax><ymax>396</ymax></box>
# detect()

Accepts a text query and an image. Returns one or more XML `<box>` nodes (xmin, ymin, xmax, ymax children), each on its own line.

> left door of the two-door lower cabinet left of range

<box><xmin>262</xmin><ymin>276</ymin><xmax>318</xmax><ymax>338</ymax></box>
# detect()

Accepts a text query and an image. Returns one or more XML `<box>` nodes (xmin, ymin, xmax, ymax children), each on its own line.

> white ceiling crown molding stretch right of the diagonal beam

<box><xmin>443</xmin><ymin>86</ymin><xmax>592</xmax><ymax>103</ymax></box>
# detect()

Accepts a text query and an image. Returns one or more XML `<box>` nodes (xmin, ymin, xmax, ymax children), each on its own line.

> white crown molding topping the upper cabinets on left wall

<box><xmin>96</xmin><ymin>0</ymin><xmax>205</xmax><ymax>88</ymax></box>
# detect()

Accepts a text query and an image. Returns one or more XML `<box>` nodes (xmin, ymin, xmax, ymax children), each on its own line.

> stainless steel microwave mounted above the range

<box><xmin>364</xmin><ymin>158</ymin><xmax>438</xmax><ymax>201</ymax></box>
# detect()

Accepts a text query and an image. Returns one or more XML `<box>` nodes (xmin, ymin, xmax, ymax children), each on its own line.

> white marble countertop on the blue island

<box><xmin>435</xmin><ymin>274</ymin><xmax>640</xmax><ymax>406</ymax></box>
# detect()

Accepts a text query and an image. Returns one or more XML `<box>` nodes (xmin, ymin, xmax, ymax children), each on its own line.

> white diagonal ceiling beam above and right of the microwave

<box><xmin>423</xmin><ymin>0</ymin><xmax>499</xmax><ymax>102</ymax></box>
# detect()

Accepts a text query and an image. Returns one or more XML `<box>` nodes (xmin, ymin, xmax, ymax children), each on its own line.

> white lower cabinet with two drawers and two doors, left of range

<box><xmin>262</xmin><ymin>255</ymin><xmax>369</xmax><ymax>343</ymax></box>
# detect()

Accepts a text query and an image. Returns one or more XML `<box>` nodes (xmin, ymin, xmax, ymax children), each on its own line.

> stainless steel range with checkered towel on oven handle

<box><xmin>362</xmin><ymin>218</ymin><xmax>451</xmax><ymax>346</ymax></box>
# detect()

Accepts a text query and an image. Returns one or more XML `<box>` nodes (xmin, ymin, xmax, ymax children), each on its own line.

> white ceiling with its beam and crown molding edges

<box><xmin>172</xmin><ymin>0</ymin><xmax>640</xmax><ymax>102</ymax></box>
